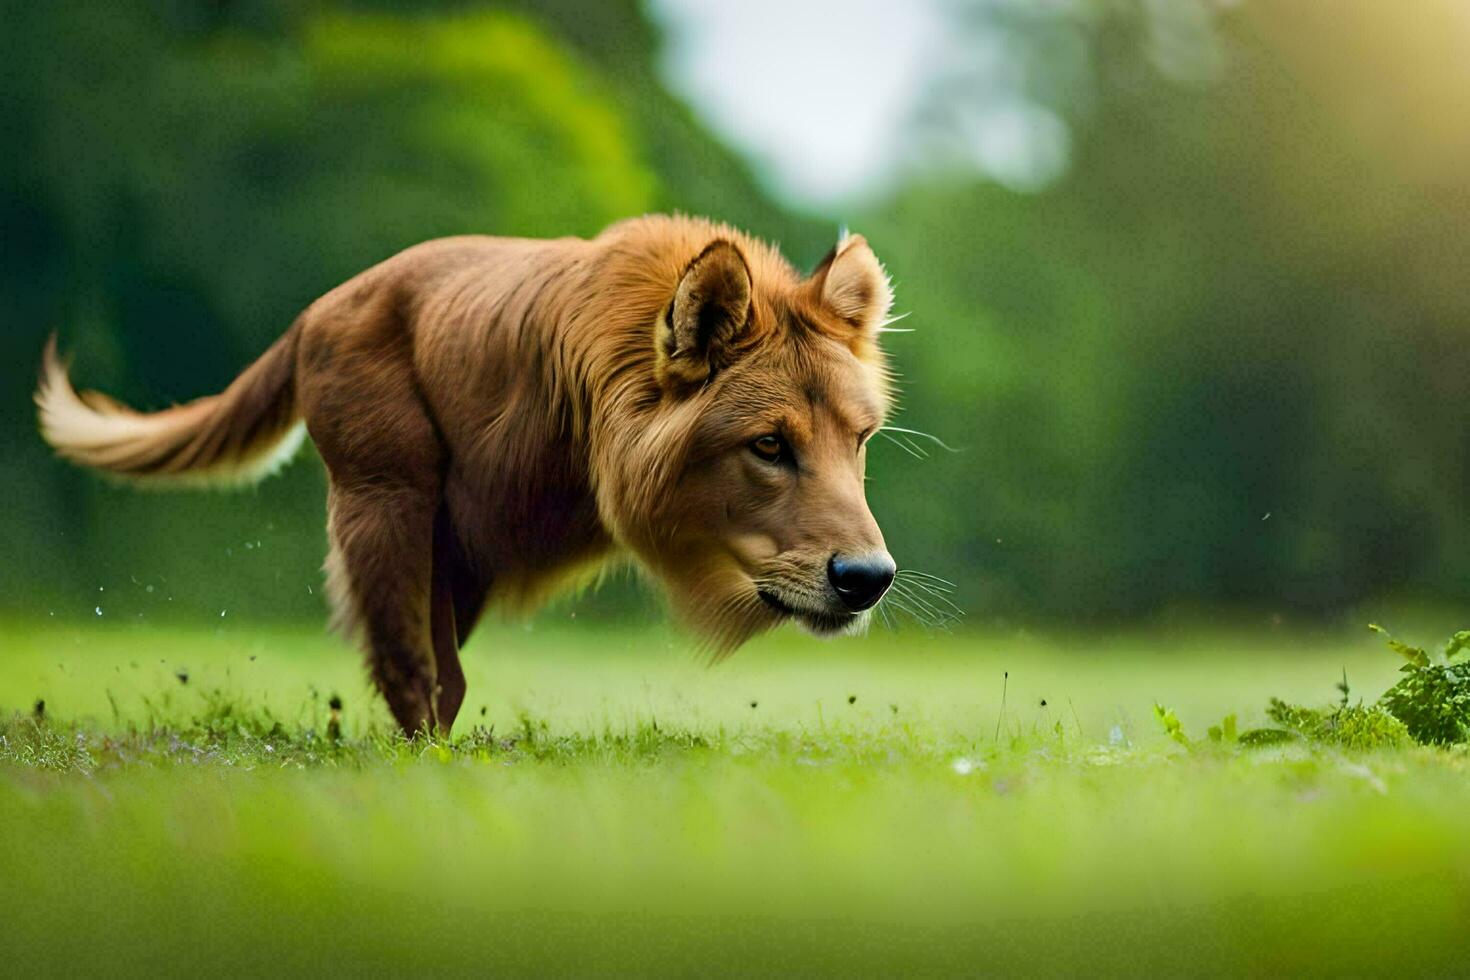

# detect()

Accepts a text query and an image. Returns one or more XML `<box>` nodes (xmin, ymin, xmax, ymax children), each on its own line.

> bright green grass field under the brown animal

<box><xmin>0</xmin><ymin>623</ymin><xmax>1470</xmax><ymax>976</ymax></box>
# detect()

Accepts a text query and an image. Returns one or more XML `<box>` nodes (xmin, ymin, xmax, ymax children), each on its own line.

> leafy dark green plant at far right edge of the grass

<box><xmin>1369</xmin><ymin>624</ymin><xmax>1470</xmax><ymax>745</ymax></box>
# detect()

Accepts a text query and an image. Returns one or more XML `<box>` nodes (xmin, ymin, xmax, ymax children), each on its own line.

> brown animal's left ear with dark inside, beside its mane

<box><xmin>654</xmin><ymin>239</ymin><xmax>751</xmax><ymax>388</ymax></box>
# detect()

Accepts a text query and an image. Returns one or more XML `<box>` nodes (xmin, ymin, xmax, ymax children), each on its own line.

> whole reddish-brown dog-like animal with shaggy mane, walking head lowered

<box><xmin>35</xmin><ymin>216</ymin><xmax>894</xmax><ymax>733</ymax></box>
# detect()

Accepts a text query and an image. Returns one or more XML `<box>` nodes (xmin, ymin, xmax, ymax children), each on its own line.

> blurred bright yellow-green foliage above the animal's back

<box><xmin>301</xmin><ymin>12</ymin><xmax>656</xmax><ymax>235</ymax></box>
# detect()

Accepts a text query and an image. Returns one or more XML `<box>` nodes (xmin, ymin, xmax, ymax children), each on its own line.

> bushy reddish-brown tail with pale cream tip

<box><xmin>35</xmin><ymin>328</ymin><xmax>304</xmax><ymax>486</ymax></box>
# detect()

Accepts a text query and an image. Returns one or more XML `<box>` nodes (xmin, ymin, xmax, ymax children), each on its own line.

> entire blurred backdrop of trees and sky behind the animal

<box><xmin>0</xmin><ymin>0</ymin><xmax>1470</xmax><ymax>627</ymax></box>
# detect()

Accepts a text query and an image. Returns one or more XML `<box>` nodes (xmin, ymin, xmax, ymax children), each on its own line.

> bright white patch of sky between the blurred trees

<box><xmin>651</xmin><ymin>0</ymin><xmax>944</xmax><ymax>203</ymax></box>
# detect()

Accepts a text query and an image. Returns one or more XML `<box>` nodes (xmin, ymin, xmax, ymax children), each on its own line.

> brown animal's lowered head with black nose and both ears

<box><xmin>635</xmin><ymin>235</ymin><xmax>895</xmax><ymax>651</ymax></box>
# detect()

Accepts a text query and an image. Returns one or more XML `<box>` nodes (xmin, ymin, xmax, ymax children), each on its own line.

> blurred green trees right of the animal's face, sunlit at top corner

<box><xmin>866</xmin><ymin>0</ymin><xmax>1470</xmax><ymax>617</ymax></box>
